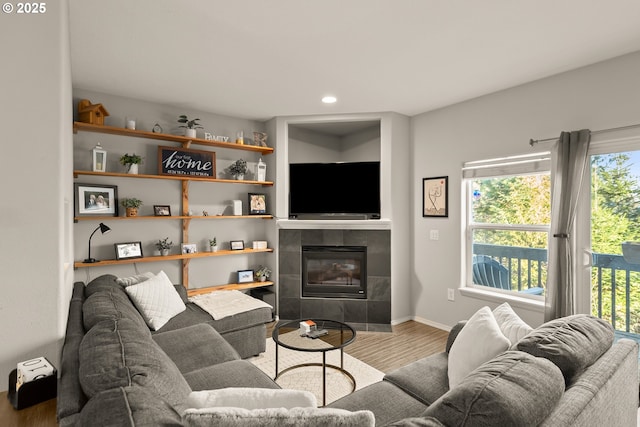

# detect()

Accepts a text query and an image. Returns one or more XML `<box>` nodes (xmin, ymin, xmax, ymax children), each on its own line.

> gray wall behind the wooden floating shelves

<box><xmin>73</xmin><ymin>89</ymin><xmax>275</xmax><ymax>288</ymax></box>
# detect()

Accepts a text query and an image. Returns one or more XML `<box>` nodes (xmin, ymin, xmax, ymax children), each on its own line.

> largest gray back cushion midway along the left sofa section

<box><xmin>79</xmin><ymin>319</ymin><xmax>191</xmax><ymax>409</ymax></box>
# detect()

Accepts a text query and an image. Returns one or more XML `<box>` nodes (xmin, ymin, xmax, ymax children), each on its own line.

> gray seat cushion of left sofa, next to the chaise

<box><xmin>153</xmin><ymin>323</ymin><xmax>240</xmax><ymax>373</ymax></box>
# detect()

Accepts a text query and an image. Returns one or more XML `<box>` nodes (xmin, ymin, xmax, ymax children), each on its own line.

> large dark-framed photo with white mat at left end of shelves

<box><xmin>73</xmin><ymin>183</ymin><xmax>118</xmax><ymax>216</ymax></box>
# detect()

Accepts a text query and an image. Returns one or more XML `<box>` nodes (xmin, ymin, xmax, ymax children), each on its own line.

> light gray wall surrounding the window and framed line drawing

<box><xmin>411</xmin><ymin>52</ymin><xmax>640</xmax><ymax>326</ymax></box>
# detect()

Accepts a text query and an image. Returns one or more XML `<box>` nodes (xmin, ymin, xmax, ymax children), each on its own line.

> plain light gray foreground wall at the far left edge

<box><xmin>0</xmin><ymin>0</ymin><xmax>73</xmax><ymax>390</ymax></box>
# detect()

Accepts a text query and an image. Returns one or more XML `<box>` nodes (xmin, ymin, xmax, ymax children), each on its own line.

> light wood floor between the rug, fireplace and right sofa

<box><xmin>267</xmin><ymin>320</ymin><xmax>449</xmax><ymax>373</ymax></box>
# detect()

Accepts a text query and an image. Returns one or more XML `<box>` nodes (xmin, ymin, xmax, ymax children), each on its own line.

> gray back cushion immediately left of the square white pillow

<box><xmin>82</xmin><ymin>291</ymin><xmax>149</xmax><ymax>330</ymax></box>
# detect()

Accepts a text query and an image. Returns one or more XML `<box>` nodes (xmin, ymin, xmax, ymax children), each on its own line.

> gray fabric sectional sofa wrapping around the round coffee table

<box><xmin>58</xmin><ymin>275</ymin><xmax>638</xmax><ymax>426</ymax></box>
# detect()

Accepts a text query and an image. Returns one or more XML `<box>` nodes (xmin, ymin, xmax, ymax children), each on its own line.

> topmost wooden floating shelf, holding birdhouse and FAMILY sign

<box><xmin>73</xmin><ymin>122</ymin><xmax>273</xmax><ymax>155</ymax></box>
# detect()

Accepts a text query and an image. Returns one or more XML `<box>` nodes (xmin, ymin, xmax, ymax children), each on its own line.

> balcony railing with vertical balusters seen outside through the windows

<box><xmin>473</xmin><ymin>243</ymin><xmax>640</xmax><ymax>334</ymax></box>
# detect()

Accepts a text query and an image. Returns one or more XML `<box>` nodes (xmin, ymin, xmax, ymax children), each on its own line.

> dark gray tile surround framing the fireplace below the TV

<box><xmin>278</xmin><ymin>229</ymin><xmax>391</xmax><ymax>332</ymax></box>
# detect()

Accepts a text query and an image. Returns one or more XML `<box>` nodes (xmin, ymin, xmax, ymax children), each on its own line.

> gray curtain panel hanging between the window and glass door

<box><xmin>544</xmin><ymin>129</ymin><xmax>591</xmax><ymax>321</ymax></box>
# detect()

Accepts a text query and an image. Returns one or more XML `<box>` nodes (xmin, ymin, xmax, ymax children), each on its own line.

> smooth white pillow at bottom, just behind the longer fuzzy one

<box><xmin>187</xmin><ymin>387</ymin><xmax>318</xmax><ymax>409</ymax></box>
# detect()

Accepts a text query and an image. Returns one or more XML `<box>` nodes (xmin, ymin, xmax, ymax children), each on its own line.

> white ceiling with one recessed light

<box><xmin>69</xmin><ymin>0</ymin><xmax>640</xmax><ymax>120</ymax></box>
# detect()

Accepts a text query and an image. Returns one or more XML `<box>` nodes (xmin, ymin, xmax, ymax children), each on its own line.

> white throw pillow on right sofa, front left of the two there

<box><xmin>448</xmin><ymin>306</ymin><xmax>511</xmax><ymax>389</ymax></box>
